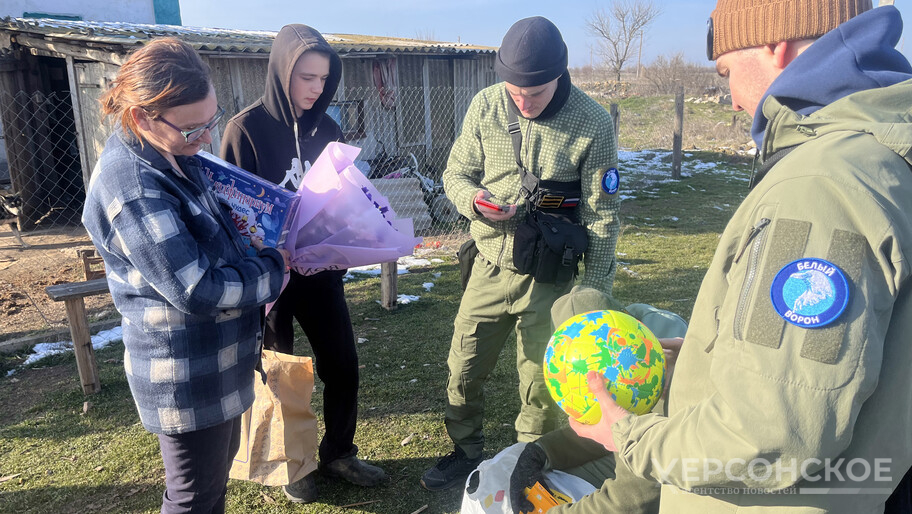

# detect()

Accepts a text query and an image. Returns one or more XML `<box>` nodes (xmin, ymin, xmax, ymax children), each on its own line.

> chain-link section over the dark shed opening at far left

<box><xmin>0</xmin><ymin>91</ymin><xmax>85</xmax><ymax>231</ymax></box>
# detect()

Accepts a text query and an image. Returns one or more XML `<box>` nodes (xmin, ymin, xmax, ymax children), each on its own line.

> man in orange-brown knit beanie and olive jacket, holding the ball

<box><xmin>558</xmin><ymin>0</ymin><xmax>912</xmax><ymax>514</ymax></box>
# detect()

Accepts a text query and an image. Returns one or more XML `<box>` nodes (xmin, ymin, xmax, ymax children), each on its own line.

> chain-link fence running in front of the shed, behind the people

<box><xmin>0</xmin><ymin>87</ymin><xmax>477</xmax><ymax>242</ymax></box>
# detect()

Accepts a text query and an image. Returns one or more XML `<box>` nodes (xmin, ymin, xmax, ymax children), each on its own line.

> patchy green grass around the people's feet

<box><xmin>0</xmin><ymin>152</ymin><xmax>749</xmax><ymax>514</ymax></box>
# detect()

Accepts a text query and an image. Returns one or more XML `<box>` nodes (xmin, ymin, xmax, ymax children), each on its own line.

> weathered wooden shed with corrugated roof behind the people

<box><xmin>0</xmin><ymin>18</ymin><xmax>497</xmax><ymax>228</ymax></box>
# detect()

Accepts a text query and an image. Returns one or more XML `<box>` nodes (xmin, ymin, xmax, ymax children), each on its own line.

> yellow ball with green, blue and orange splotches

<box><xmin>544</xmin><ymin>311</ymin><xmax>665</xmax><ymax>425</ymax></box>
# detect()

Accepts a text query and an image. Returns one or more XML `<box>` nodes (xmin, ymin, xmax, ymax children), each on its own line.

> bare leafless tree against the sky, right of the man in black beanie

<box><xmin>586</xmin><ymin>0</ymin><xmax>662</xmax><ymax>82</ymax></box>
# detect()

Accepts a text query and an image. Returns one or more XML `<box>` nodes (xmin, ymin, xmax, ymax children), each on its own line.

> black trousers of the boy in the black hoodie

<box><xmin>263</xmin><ymin>271</ymin><xmax>358</xmax><ymax>463</ymax></box>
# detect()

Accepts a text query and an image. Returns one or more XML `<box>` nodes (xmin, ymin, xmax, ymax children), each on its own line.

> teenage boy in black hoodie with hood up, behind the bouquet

<box><xmin>221</xmin><ymin>25</ymin><xmax>387</xmax><ymax>503</ymax></box>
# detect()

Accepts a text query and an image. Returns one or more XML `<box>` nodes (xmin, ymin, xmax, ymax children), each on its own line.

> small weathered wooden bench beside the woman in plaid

<box><xmin>44</xmin><ymin>278</ymin><xmax>108</xmax><ymax>394</ymax></box>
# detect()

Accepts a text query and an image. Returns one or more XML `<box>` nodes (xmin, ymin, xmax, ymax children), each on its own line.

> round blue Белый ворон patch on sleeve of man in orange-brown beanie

<box><xmin>770</xmin><ymin>258</ymin><xmax>849</xmax><ymax>328</ymax></box>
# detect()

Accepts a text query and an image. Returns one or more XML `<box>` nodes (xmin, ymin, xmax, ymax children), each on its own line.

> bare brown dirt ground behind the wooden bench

<box><xmin>0</xmin><ymin>225</ymin><xmax>116</xmax><ymax>342</ymax></box>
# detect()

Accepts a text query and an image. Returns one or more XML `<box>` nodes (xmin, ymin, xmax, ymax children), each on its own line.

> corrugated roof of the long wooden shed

<box><xmin>0</xmin><ymin>18</ymin><xmax>496</xmax><ymax>54</ymax></box>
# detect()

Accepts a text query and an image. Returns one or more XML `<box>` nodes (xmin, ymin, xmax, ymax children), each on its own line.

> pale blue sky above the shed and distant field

<box><xmin>180</xmin><ymin>0</ymin><xmax>912</xmax><ymax>67</ymax></box>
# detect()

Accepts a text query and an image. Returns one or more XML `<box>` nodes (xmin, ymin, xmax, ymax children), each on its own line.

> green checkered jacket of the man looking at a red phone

<box><xmin>443</xmin><ymin>83</ymin><xmax>620</xmax><ymax>295</ymax></box>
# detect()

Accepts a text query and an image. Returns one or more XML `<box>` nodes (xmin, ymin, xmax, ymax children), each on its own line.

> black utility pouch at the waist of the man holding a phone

<box><xmin>513</xmin><ymin>210</ymin><xmax>589</xmax><ymax>284</ymax></box>
